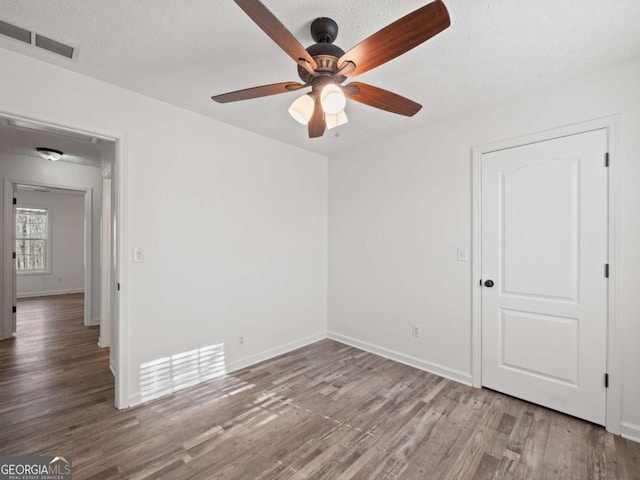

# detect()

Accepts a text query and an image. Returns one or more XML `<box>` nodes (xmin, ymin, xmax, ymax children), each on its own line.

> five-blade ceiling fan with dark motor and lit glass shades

<box><xmin>212</xmin><ymin>0</ymin><xmax>451</xmax><ymax>138</ymax></box>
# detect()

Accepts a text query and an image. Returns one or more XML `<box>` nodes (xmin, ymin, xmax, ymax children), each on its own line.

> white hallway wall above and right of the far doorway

<box><xmin>0</xmin><ymin>154</ymin><xmax>102</xmax><ymax>318</ymax></box>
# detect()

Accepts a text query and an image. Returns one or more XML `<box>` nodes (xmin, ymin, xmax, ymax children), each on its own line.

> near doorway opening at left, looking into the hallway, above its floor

<box><xmin>0</xmin><ymin>113</ymin><xmax>128</xmax><ymax>408</ymax></box>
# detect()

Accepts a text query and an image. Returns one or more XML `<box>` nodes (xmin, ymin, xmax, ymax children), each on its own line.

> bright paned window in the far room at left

<box><xmin>16</xmin><ymin>207</ymin><xmax>49</xmax><ymax>273</ymax></box>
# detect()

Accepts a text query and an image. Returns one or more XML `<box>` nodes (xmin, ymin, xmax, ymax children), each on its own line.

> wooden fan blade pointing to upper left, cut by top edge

<box><xmin>235</xmin><ymin>0</ymin><xmax>318</xmax><ymax>70</ymax></box>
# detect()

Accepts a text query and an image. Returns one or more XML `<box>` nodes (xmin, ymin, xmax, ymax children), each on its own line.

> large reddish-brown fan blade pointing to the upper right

<box><xmin>338</xmin><ymin>0</ymin><xmax>451</xmax><ymax>77</ymax></box>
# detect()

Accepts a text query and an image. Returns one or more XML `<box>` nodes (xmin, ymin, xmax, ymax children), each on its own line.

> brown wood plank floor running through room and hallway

<box><xmin>0</xmin><ymin>295</ymin><xmax>640</xmax><ymax>480</ymax></box>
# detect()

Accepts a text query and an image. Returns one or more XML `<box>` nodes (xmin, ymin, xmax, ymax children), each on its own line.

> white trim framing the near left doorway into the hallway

<box><xmin>0</xmin><ymin>110</ymin><xmax>130</xmax><ymax>408</ymax></box>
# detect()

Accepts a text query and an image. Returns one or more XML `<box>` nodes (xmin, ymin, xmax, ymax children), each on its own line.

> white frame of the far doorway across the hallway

<box><xmin>4</xmin><ymin>178</ymin><xmax>94</xmax><ymax>326</ymax></box>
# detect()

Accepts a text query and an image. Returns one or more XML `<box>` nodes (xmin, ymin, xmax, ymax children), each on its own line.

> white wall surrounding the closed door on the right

<box><xmin>329</xmin><ymin>61</ymin><xmax>640</xmax><ymax>438</ymax></box>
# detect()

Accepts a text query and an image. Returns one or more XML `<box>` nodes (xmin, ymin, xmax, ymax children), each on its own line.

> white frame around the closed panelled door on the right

<box><xmin>471</xmin><ymin>115</ymin><xmax>622</xmax><ymax>434</ymax></box>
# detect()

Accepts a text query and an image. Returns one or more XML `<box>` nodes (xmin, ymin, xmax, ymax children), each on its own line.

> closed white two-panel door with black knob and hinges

<box><xmin>481</xmin><ymin>129</ymin><xmax>608</xmax><ymax>425</ymax></box>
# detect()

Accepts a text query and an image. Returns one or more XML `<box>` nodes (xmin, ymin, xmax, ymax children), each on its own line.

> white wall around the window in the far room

<box><xmin>15</xmin><ymin>190</ymin><xmax>84</xmax><ymax>297</ymax></box>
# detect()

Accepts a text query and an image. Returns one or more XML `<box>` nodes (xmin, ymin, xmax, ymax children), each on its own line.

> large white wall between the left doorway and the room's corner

<box><xmin>0</xmin><ymin>50</ymin><xmax>327</xmax><ymax>402</ymax></box>
